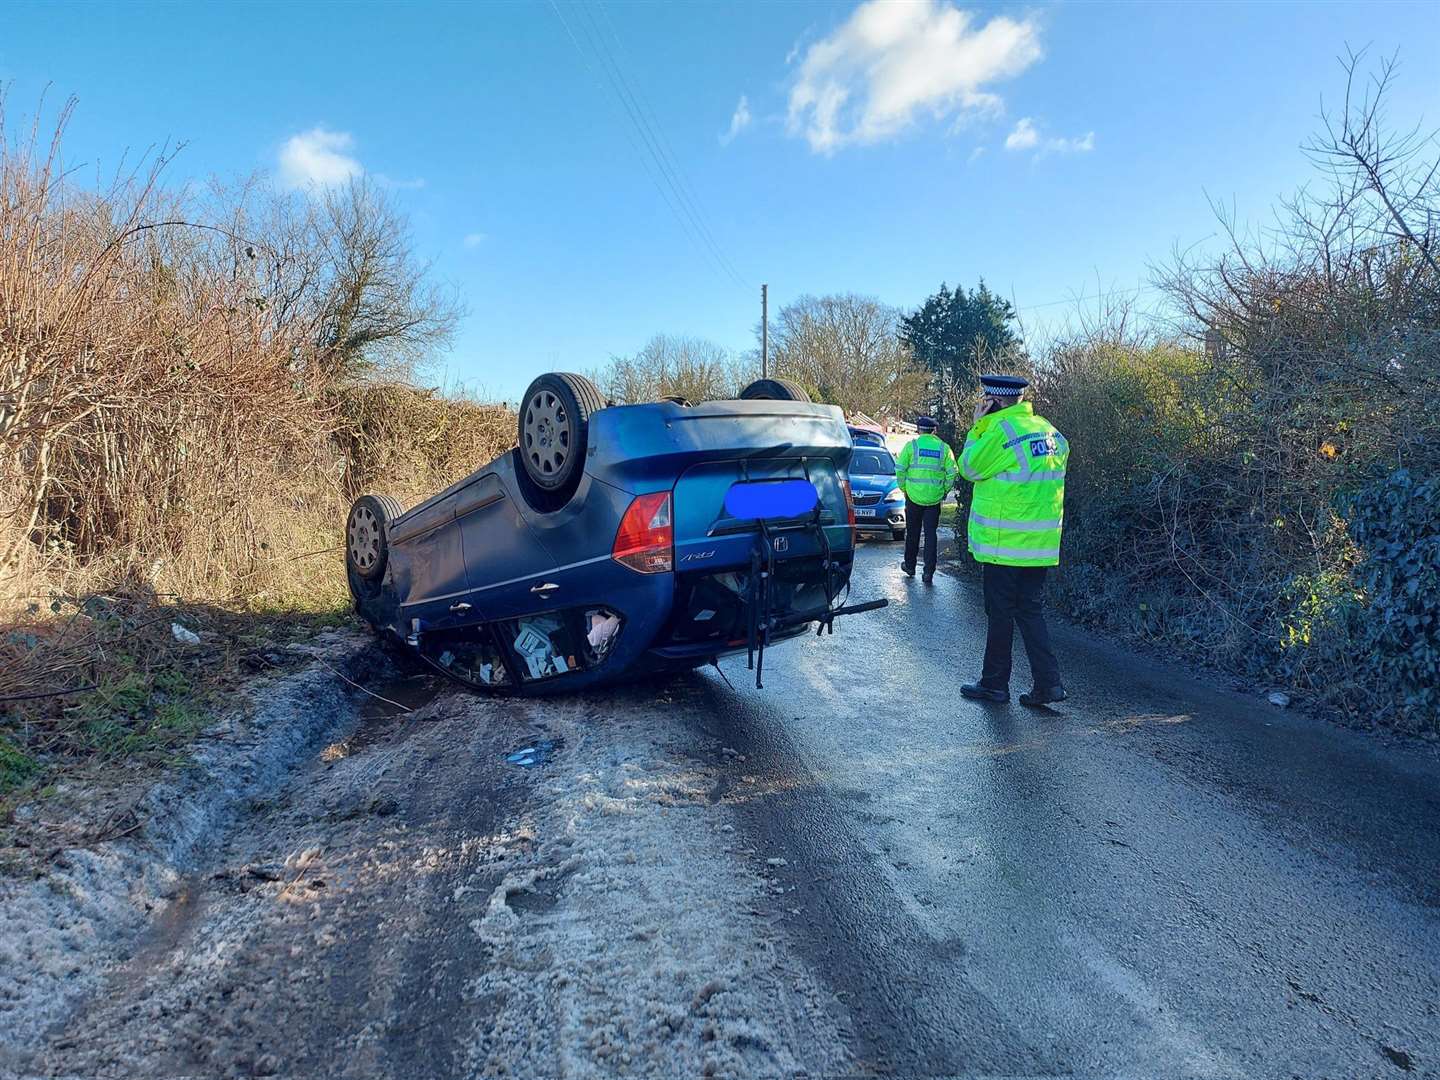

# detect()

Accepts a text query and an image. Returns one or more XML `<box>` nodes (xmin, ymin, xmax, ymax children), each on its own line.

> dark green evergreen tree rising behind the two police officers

<box><xmin>900</xmin><ymin>279</ymin><xmax>1024</xmax><ymax>438</ymax></box>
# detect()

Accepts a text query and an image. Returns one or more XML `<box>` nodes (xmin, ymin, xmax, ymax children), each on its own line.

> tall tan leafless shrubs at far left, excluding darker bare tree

<box><xmin>0</xmin><ymin>101</ymin><xmax>341</xmax><ymax>616</ymax></box>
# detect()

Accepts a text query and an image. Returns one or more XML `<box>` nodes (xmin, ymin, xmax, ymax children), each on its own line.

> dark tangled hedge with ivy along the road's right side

<box><xmin>1037</xmin><ymin>48</ymin><xmax>1440</xmax><ymax>730</ymax></box>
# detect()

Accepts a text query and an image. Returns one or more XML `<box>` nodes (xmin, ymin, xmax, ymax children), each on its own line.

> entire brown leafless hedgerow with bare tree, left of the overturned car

<box><xmin>0</xmin><ymin>107</ymin><xmax>483</xmax><ymax>624</ymax></box>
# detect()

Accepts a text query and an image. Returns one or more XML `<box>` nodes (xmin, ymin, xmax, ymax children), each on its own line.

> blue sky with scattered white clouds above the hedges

<box><xmin>0</xmin><ymin>0</ymin><xmax>1440</xmax><ymax>397</ymax></box>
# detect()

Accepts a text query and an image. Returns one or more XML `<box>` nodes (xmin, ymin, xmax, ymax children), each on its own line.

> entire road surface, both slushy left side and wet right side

<box><xmin>22</xmin><ymin>543</ymin><xmax>1440</xmax><ymax>1077</ymax></box>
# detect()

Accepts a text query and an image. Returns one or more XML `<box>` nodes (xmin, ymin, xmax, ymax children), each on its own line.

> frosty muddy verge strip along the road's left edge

<box><xmin>0</xmin><ymin>632</ymin><xmax>386</xmax><ymax>1066</ymax></box>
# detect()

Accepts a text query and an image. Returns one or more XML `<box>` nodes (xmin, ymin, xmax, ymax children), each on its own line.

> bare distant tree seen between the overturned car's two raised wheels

<box><xmin>592</xmin><ymin>334</ymin><xmax>749</xmax><ymax>405</ymax></box>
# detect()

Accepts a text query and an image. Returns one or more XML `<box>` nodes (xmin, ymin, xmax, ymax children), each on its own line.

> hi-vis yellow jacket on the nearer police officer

<box><xmin>960</xmin><ymin>402</ymin><xmax>1070</xmax><ymax>566</ymax></box>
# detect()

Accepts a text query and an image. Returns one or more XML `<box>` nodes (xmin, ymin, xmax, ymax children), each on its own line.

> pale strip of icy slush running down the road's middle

<box><xmin>462</xmin><ymin>696</ymin><xmax>850</xmax><ymax>1077</ymax></box>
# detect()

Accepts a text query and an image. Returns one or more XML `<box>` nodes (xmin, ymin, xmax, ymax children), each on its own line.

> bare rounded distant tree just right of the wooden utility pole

<box><xmin>770</xmin><ymin>294</ymin><xmax>929</xmax><ymax>418</ymax></box>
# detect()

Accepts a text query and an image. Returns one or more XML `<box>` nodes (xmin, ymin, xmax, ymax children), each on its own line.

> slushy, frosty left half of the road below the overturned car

<box><xmin>20</xmin><ymin>685</ymin><xmax>845</xmax><ymax>1076</ymax></box>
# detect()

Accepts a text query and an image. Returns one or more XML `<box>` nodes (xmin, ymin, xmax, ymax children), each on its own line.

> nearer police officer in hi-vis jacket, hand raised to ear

<box><xmin>960</xmin><ymin>374</ymin><xmax>1070</xmax><ymax>706</ymax></box>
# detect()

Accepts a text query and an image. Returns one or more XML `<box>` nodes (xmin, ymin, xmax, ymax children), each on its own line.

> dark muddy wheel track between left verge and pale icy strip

<box><xmin>26</xmin><ymin>691</ymin><xmax>544</xmax><ymax>1076</ymax></box>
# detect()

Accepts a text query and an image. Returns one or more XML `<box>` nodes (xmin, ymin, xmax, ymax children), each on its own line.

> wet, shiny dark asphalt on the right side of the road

<box><xmin>713</xmin><ymin>546</ymin><xmax>1440</xmax><ymax>1076</ymax></box>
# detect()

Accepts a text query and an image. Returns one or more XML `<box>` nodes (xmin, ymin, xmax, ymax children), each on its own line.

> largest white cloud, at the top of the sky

<box><xmin>789</xmin><ymin>0</ymin><xmax>1043</xmax><ymax>154</ymax></box>
